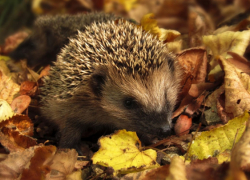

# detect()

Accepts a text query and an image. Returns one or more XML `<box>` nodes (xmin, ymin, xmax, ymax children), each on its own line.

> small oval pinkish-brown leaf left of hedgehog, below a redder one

<box><xmin>11</xmin><ymin>95</ymin><xmax>31</xmax><ymax>114</ymax></box>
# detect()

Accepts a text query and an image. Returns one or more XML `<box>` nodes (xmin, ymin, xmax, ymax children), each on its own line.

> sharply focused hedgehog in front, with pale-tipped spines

<box><xmin>38</xmin><ymin>14</ymin><xmax>181</xmax><ymax>152</ymax></box>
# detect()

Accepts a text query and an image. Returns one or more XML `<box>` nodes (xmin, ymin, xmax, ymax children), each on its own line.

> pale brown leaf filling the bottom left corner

<box><xmin>0</xmin><ymin>146</ymin><xmax>42</xmax><ymax>180</ymax></box>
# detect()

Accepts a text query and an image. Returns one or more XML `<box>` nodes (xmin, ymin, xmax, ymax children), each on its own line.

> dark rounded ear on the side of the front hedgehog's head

<box><xmin>90</xmin><ymin>68</ymin><xmax>107</xmax><ymax>97</ymax></box>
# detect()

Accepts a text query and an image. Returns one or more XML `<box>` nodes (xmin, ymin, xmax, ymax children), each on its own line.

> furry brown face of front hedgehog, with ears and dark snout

<box><xmin>93</xmin><ymin>58</ymin><xmax>178</xmax><ymax>135</ymax></box>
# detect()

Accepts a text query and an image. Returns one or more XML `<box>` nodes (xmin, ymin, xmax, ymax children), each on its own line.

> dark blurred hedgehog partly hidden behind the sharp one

<box><xmin>8</xmin><ymin>13</ymin><xmax>118</xmax><ymax>71</ymax></box>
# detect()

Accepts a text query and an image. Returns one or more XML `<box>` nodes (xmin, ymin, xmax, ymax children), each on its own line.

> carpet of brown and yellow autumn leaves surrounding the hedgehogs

<box><xmin>0</xmin><ymin>0</ymin><xmax>250</xmax><ymax>180</ymax></box>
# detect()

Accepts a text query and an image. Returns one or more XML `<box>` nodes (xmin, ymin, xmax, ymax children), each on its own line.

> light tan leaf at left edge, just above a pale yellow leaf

<box><xmin>0</xmin><ymin>61</ymin><xmax>20</xmax><ymax>104</ymax></box>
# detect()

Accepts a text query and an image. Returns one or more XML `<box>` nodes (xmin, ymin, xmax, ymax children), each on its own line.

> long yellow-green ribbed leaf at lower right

<box><xmin>188</xmin><ymin>112</ymin><xmax>249</xmax><ymax>159</ymax></box>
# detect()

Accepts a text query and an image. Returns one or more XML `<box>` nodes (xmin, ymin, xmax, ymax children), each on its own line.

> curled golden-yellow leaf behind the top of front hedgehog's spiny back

<box><xmin>141</xmin><ymin>13</ymin><xmax>181</xmax><ymax>42</ymax></box>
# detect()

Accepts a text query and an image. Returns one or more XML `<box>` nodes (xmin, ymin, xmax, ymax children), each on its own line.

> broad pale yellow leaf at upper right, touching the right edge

<box><xmin>203</xmin><ymin>30</ymin><xmax>250</xmax><ymax>79</ymax></box>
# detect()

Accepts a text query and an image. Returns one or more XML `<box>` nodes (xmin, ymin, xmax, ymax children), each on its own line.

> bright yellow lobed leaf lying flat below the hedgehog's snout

<box><xmin>92</xmin><ymin>130</ymin><xmax>159</xmax><ymax>174</ymax></box>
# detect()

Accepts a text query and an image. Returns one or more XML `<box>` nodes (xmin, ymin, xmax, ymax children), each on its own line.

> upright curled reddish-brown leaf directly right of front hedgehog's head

<box><xmin>177</xmin><ymin>48</ymin><xmax>207</xmax><ymax>99</ymax></box>
